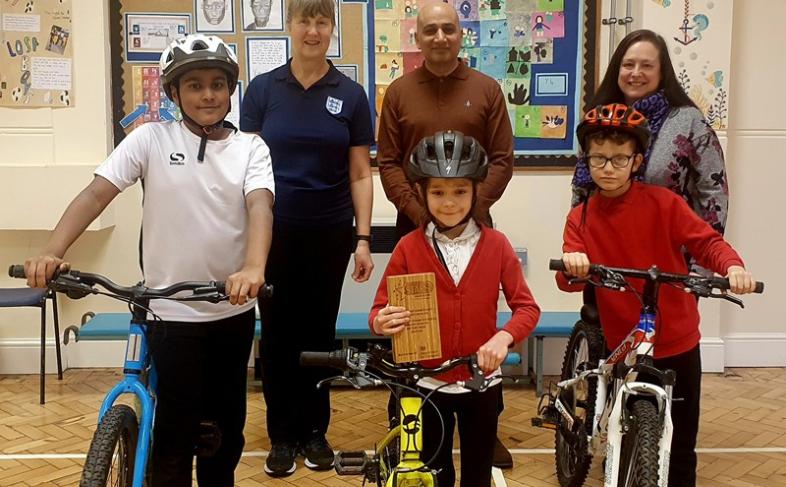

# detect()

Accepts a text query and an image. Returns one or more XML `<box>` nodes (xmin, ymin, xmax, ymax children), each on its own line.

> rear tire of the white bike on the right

<box><xmin>554</xmin><ymin>320</ymin><xmax>604</xmax><ymax>487</ymax></box>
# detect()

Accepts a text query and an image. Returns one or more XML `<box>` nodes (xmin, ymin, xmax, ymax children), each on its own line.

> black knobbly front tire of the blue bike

<box><xmin>79</xmin><ymin>405</ymin><xmax>139</xmax><ymax>487</ymax></box>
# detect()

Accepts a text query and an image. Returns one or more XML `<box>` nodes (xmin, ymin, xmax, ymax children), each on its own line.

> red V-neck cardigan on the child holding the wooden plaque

<box><xmin>369</xmin><ymin>226</ymin><xmax>540</xmax><ymax>382</ymax></box>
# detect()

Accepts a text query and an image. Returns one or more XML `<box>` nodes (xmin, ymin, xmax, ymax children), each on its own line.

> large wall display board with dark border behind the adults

<box><xmin>110</xmin><ymin>0</ymin><xmax>597</xmax><ymax>166</ymax></box>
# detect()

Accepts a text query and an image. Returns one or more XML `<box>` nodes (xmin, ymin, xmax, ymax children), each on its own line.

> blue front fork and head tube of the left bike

<box><xmin>98</xmin><ymin>317</ymin><xmax>157</xmax><ymax>487</ymax></box>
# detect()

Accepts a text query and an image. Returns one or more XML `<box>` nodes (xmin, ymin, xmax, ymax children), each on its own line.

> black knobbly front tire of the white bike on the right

<box><xmin>617</xmin><ymin>399</ymin><xmax>661</xmax><ymax>487</ymax></box>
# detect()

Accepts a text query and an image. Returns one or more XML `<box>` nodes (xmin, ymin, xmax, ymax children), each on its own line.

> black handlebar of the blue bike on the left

<box><xmin>8</xmin><ymin>264</ymin><xmax>273</xmax><ymax>302</ymax></box>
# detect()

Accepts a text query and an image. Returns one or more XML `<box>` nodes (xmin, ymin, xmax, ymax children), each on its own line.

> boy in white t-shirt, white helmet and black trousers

<box><xmin>25</xmin><ymin>34</ymin><xmax>274</xmax><ymax>487</ymax></box>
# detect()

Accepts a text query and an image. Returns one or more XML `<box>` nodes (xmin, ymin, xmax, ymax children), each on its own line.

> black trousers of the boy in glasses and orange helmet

<box><xmin>654</xmin><ymin>345</ymin><xmax>701</xmax><ymax>487</ymax></box>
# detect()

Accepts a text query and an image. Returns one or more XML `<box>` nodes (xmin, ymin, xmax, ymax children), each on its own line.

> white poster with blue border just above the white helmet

<box><xmin>125</xmin><ymin>13</ymin><xmax>191</xmax><ymax>62</ymax></box>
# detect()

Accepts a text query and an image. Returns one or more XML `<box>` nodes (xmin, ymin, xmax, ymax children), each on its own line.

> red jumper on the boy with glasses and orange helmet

<box><xmin>557</xmin><ymin>183</ymin><xmax>743</xmax><ymax>358</ymax></box>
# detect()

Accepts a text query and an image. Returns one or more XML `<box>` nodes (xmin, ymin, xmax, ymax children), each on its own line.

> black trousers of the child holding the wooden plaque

<box><xmin>421</xmin><ymin>385</ymin><xmax>502</xmax><ymax>487</ymax></box>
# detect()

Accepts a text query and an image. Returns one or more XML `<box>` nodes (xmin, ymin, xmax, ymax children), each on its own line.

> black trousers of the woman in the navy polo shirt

<box><xmin>259</xmin><ymin>221</ymin><xmax>353</xmax><ymax>443</ymax></box>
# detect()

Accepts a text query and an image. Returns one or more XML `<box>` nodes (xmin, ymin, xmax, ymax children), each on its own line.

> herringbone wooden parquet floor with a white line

<box><xmin>0</xmin><ymin>369</ymin><xmax>786</xmax><ymax>487</ymax></box>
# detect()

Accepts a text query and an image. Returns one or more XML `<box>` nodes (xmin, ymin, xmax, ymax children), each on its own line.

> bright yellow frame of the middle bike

<box><xmin>377</xmin><ymin>397</ymin><xmax>437</xmax><ymax>487</ymax></box>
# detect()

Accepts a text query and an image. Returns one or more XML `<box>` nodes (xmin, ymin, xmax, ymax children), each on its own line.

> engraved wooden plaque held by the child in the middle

<box><xmin>388</xmin><ymin>272</ymin><xmax>442</xmax><ymax>363</ymax></box>
